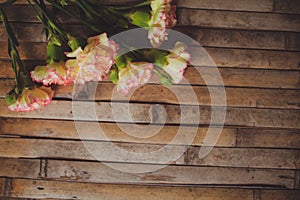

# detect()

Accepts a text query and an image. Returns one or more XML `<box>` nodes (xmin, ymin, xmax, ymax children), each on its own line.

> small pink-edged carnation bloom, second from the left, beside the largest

<box><xmin>30</xmin><ymin>61</ymin><xmax>72</xmax><ymax>86</ymax></box>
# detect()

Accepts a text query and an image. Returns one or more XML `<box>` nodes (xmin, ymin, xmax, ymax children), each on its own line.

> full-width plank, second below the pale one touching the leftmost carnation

<box><xmin>0</xmin><ymin>138</ymin><xmax>300</xmax><ymax>169</ymax></box>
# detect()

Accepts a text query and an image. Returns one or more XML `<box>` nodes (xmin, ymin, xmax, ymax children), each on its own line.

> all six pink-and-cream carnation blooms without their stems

<box><xmin>9</xmin><ymin>0</ymin><xmax>190</xmax><ymax>112</ymax></box>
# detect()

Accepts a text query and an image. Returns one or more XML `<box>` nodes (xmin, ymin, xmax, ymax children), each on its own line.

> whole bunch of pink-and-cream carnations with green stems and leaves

<box><xmin>0</xmin><ymin>0</ymin><xmax>190</xmax><ymax>112</ymax></box>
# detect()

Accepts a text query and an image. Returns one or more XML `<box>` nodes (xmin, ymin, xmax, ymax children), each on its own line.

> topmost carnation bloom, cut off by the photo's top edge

<box><xmin>148</xmin><ymin>0</ymin><xmax>176</xmax><ymax>47</ymax></box>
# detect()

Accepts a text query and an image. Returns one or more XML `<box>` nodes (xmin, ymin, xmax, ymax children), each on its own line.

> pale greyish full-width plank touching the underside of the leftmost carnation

<box><xmin>0</xmin><ymin>99</ymin><xmax>300</xmax><ymax>128</ymax></box>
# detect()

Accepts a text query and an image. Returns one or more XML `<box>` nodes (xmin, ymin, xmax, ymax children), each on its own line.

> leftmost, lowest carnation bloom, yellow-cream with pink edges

<box><xmin>8</xmin><ymin>86</ymin><xmax>54</xmax><ymax>112</ymax></box>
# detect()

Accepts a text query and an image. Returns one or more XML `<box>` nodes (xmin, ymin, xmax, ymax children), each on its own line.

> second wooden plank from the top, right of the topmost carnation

<box><xmin>178</xmin><ymin>9</ymin><xmax>300</xmax><ymax>32</ymax></box>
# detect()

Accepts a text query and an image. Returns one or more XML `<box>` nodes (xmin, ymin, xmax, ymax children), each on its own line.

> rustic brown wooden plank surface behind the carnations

<box><xmin>0</xmin><ymin>0</ymin><xmax>300</xmax><ymax>200</ymax></box>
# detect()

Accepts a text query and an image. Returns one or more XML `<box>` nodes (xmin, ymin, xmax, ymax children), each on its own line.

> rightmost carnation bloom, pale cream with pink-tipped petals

<box><xmin>162</xmin><ymin>42</ymin><xmax>190</xmax><ymax>83</ymax></box>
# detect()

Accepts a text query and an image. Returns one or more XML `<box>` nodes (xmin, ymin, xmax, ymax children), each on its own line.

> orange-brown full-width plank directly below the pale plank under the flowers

<box><xmin>0</xmin><ymin>118</ymin><xmax>300</xmax><ymax>149</ymax></box>
